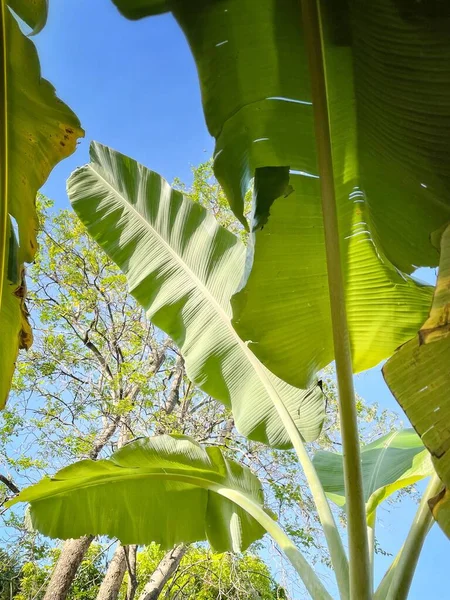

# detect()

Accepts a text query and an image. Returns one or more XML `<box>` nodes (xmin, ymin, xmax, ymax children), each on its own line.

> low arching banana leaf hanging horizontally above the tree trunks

<box><xmin>8</xmin><ymin>435</ymin><xmax>265</xmax><ymax>552</ymax></box>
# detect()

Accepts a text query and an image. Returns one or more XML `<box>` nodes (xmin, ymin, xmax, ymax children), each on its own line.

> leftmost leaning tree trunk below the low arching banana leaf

<box><xmin>44</xmin><ymin>535</ymin><xmax>94</xmax><ymax>600</ymax></box>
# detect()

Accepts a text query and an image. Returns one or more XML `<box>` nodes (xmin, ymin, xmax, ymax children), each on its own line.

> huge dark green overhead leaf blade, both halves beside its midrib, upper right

<box><xmin>110</xmin><ymin>0</ymin><xmax>442</xmax><ymax>386</ymax></box>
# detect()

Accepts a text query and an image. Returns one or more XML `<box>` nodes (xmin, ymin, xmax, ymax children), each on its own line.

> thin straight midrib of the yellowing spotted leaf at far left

<box><xmin>0</xmin><ymin>0</ymin><xmax>8</xmax><ymax>310</ymax></box>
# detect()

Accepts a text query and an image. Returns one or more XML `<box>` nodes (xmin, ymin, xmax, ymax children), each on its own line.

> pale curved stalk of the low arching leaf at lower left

<box><xmin>221</xmin><ymin>487</ymin><xmax>333</xmax><ymax>600</ymax></box>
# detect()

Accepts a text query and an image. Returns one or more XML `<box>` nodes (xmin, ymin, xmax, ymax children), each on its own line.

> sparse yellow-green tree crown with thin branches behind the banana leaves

<box><xmin>0</xmin><ymin>161</ymin><xmax>428</xmax><ymax>597</ymax></box>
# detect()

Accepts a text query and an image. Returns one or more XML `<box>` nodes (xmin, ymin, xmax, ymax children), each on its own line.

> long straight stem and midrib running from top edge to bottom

<box><xmin>302</xmin><ymin>0</ymin><xmax>372</xmax><ymax>600</ymax></box>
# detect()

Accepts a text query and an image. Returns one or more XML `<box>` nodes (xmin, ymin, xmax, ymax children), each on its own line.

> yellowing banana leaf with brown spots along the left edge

<box><xmin>0</xmin><ymin>0</ymin><xmax>83</xmax><ymax>408</ymax></box>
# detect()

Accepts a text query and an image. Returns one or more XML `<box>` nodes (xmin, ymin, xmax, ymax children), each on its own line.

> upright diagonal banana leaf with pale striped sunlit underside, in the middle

<box><xmin>68</xmin><ymin>143</ymin><xmax>325</xmax><ymax>447</ymax></box>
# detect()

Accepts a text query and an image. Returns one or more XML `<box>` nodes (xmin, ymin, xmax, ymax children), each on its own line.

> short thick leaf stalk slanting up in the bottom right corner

<box><xmin>380</xmin><ymin>475</ymin><xmax>442</xmax><ymax>600</ymax></box>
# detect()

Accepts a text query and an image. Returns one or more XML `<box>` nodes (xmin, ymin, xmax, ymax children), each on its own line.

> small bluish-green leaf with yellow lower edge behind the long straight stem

<box><xmin>313</xmin><ymin>429</ymin><xmax>433</xmax><ymax>525</ymax></box>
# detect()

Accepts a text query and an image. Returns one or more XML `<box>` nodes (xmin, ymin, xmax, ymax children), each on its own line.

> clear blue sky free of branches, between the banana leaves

<box><xmin>35</xmin><ymin>0</ymin><xmax>449</xmax><ymax>600</ymax></box>
